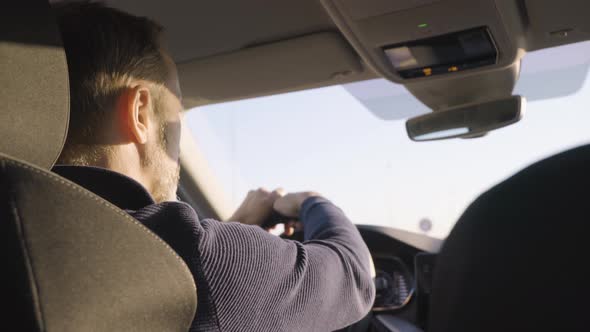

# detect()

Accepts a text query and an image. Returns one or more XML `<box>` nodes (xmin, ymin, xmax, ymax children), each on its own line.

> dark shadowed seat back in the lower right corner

<box><xmin>429</xmin><ymin>146</ymin><xmax>590</xmax><ymax>332</ymax></box>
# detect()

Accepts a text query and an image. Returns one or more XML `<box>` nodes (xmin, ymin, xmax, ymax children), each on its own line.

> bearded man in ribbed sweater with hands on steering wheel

<box><xmin>54</xmin><ymin>3</ymin><xmax>374</xmax><ymax>331</ymax></box>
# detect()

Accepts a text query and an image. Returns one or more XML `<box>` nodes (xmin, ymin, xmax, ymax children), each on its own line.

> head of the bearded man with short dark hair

<box><xmin>54</xmin><ymin>2</ymin><xmax>182</xmax><ymax>201</ymax></box>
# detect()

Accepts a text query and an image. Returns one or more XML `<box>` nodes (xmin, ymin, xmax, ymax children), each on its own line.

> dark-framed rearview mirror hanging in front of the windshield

<box><xmin>406</xmin><ymin>96</ymin><xmax>526</xmax><ymax>142</ymax></box>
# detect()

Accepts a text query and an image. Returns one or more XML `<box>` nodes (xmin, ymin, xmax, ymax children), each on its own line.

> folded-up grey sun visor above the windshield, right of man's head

<box><xmin>178</xmin><ymin>32</ymin><xmax>363</xmax><ymax>107</ymax></box>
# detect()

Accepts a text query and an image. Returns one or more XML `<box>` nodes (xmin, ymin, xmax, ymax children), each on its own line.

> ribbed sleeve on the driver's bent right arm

<box><xmin>198</xmin><ymin>197</ymin><xmax>375</xmax><ymax>331</ymax></box>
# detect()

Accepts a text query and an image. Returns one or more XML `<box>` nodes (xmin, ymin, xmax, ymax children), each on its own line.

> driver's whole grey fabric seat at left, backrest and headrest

<box><xmin>0</xmin><ymin>0</ymin><xmax>197</xmax><ymax>331</ymax></box>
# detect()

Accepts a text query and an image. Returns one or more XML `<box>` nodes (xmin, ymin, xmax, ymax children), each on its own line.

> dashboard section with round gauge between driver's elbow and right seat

<box><xmin>343</xmin><ymin>225</ymin><xmax>443</xmax><ymax>332</ymax></box>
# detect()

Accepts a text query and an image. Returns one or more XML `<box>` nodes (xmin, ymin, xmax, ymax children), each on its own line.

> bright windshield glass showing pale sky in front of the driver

<box><xmin>186</xmin><ymin>42</ymin><xmax>590</xmax><ymax>238</ymax></box>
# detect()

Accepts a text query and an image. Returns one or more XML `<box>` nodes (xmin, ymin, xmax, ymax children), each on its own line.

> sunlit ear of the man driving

<box><xmin>118</xmin><ymin>85</ymin><xmax>154</xmax><ymax>144</ymax></box>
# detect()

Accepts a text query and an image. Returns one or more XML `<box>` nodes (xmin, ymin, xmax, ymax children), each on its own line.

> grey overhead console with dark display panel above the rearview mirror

<box><xmin>322</xmin><ymin>0</ymin><xmax>524</xmax><ymax>84</ymax></box>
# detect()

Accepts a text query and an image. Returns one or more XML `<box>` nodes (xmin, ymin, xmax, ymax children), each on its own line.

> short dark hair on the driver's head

<box><xmin>53</xmin><ymin>1</ymin><xmax>169</xmax><ymax>164</ymax></box>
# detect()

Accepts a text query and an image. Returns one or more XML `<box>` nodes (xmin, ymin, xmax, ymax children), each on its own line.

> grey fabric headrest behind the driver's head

<box><xmin>0</xmin><ymin>0</ymin><xmax>70</xmax><ymax>169</ymax></box>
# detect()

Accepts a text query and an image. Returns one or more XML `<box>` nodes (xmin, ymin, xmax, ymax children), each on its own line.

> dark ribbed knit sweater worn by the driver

<box><xmin>53</xmin><ymin>166</ymin><xmax>375</xmax><ymax>331</ymax></box>
